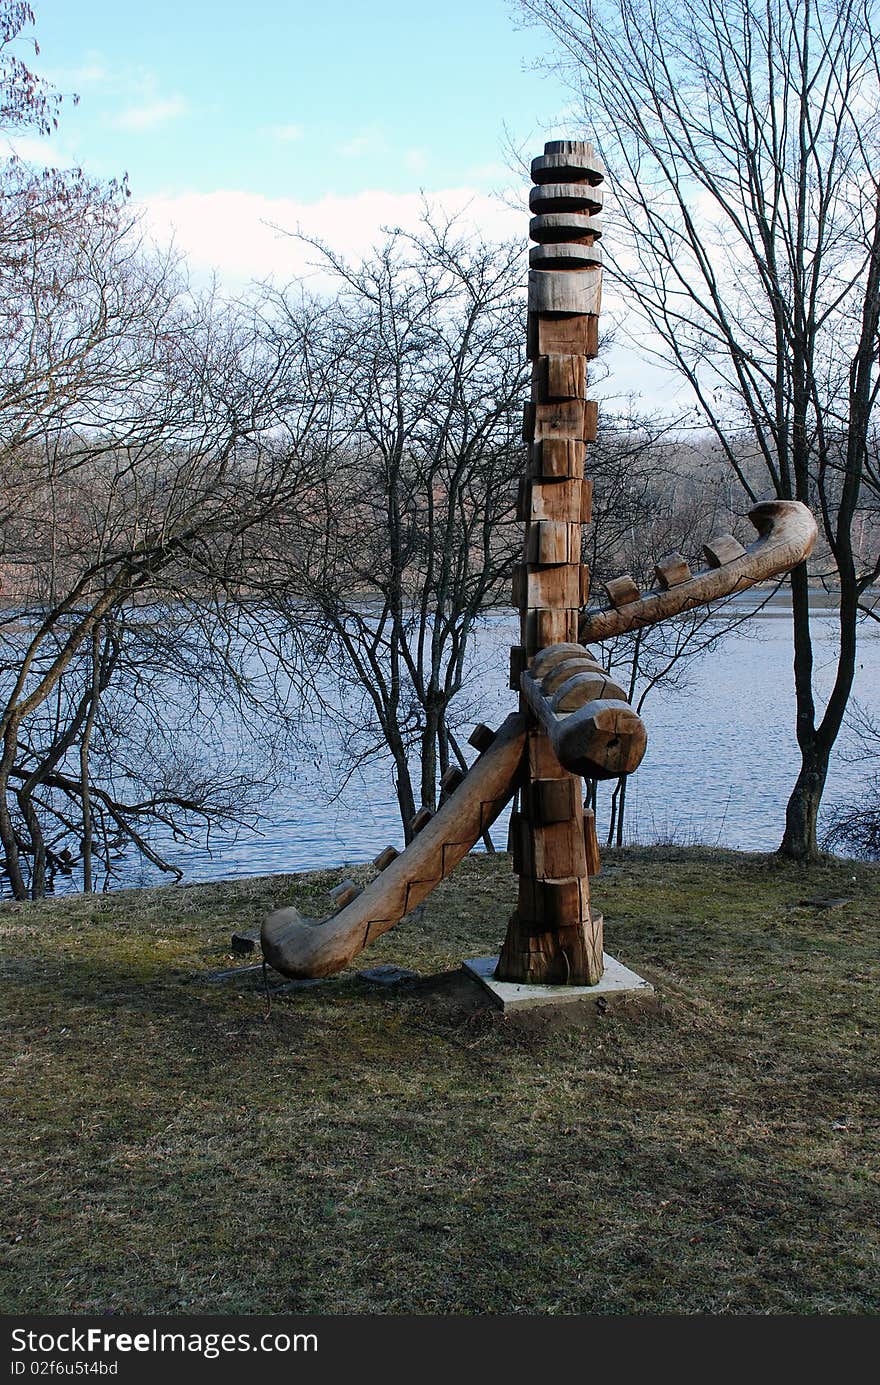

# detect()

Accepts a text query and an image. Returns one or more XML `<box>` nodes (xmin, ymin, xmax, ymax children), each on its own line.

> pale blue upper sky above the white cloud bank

<box><xmin>35</xmin><ymin>0</ymin><xmax>567</xmax><ymax>201</ymax></box>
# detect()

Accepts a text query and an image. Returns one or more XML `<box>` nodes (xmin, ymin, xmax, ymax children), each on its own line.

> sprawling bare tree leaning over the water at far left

<box><xmin>0</xmin><ymin>154</ymin><xmax>324</xmax><ymax>899</ymax></box>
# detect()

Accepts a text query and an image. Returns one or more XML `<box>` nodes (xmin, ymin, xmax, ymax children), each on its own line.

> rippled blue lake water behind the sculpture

<box><xmin>115</xmin><ymin>594</ymin><xmax>880</xmax><ymax>888</ymax></box>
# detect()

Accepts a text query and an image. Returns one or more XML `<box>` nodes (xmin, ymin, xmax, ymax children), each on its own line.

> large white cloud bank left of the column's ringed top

<box><xmin>143</xmin><ymin>187</ymin><xmax>528</xmax><ymax>291</ymax></box>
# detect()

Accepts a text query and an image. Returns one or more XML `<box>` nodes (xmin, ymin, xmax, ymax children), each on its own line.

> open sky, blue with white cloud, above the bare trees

<box><xmin>6</xmin><ymin>0</ymin><xmax>679</xmax><ymax>404</ymax></box>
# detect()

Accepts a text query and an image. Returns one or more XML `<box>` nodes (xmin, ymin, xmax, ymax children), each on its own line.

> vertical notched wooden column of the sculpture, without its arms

<box><xmin>496</xmin><ymin>140</ymin><xmax>603</xmax><ymax>985</ymax></box>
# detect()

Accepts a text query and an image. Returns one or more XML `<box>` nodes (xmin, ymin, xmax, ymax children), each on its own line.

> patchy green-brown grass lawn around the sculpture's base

<box><xmin>0</xmin><ymin>849</ymin><xmax>880</xmax><ymax>1314</ymax></box>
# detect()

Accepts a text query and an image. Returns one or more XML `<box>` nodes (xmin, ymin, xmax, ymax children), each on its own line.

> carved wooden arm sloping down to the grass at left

<box><xmin>262</xmin><ymin>712</ymin><xmax>527</xmax><ymax>978</ymax></box>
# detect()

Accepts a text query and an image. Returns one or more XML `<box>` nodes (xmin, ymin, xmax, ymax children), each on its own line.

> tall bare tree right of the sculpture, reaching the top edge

<box><xmin>521</xmin><ymin>0</ymin><xmax>880</xmax><ymax>859</ymax></box>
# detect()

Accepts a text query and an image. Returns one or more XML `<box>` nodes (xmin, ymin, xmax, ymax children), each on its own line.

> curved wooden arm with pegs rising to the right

<box><xmin>578</xmin><ymin>500</ymin><xmax>818</xmax><ymax>643</ymax></box>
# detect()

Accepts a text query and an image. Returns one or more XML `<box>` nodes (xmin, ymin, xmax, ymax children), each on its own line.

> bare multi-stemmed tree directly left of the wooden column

<box><xmin>254</xmin><ymin>220</ymin><xmax>528</xmax><ymax>838</ymax></box>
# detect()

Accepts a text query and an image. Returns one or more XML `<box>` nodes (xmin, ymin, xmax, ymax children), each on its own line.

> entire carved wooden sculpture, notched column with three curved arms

<box><xmin>262</xmin><ymin>140</ymin><xmax>816</xmax><ymax>985</ymax></box>
